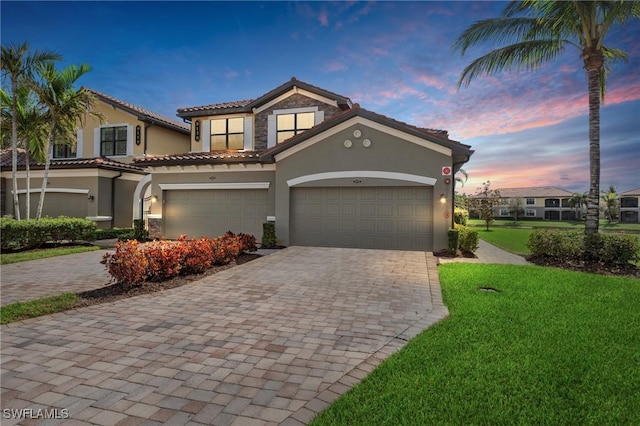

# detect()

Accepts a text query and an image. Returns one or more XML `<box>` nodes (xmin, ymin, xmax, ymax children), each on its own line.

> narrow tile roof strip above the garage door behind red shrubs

<box><xmin>133</xmin><ymin>151</ymin><xmax>260</xmax><ymax>167</ymax></box>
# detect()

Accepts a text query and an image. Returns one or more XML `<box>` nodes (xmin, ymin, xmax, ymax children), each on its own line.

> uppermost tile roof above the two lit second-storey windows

<box><xmin>178</xmin><ymin>77</ymin><xmax>351</xmax><ymax>118</ymax></box>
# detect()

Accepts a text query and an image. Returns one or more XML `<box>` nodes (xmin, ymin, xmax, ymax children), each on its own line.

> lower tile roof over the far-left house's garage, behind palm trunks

<box><xmin>0</xmin><ymin>148</ymin><xmax>145</xmax><ymax>173</ymax></box>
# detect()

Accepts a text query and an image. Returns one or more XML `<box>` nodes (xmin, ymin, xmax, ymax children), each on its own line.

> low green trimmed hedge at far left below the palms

<box><xmin>0</xmin><ymin>216</ymin><xmax>96</xmax><ymax>251</ymax></box>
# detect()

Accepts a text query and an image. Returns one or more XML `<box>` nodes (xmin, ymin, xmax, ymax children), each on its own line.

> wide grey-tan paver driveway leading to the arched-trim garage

<box><xmin>1</xmin><ymin>247</ymin><xmax>447</xmax><ymax>425</ymax></box>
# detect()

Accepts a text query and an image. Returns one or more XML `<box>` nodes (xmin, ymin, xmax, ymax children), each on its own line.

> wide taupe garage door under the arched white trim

<box><xmin>291</xmin><ymin>186</ymin><xmax>433</xmax><ymax>251</ymax></box>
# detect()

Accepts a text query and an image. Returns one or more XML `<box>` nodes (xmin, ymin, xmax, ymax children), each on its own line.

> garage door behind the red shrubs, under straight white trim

<box><xmin>163</xmin><ymin>189</ymin><xmax>269</xmax><ymax>240</ymax></box>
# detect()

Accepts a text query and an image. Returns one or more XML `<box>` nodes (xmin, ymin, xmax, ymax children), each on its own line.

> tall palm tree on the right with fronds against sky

<box><xmin>454</xmin><ymin>0</ymin><xmax>640</xmax><ymax>245</ymax></box>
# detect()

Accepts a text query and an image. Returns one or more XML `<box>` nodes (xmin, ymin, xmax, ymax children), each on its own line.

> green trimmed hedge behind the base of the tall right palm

<box><xmin>527</xmin><ymin>229</ymin><xmax>640</xmax><ymax>265</ymax></box>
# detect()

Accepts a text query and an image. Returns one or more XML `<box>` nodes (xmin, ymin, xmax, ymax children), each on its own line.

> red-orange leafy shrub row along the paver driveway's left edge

<box><xmin>100</xmin><ymin>232</ymin><xmax>257</xmax><ymax>285</ymax></box>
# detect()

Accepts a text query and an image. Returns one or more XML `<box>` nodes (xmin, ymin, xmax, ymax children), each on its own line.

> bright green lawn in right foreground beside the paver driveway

<box><xmin>312</xmin><ymin>264</ymin><xmax>640</xmax><ymax>426</ymax></box>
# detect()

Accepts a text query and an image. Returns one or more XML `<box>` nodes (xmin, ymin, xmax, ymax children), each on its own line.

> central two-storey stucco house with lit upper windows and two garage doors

<box><xmin>134</xmin><ymin>78</ymin><xmax>473</xmax><ymax>250</ymax></box>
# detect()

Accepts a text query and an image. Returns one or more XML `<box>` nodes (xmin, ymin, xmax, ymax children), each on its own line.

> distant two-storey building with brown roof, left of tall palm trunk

<box><xmin>494</xmin><ymin>186</ymin><xmax>580</xmax><ymax>220</ymax></box>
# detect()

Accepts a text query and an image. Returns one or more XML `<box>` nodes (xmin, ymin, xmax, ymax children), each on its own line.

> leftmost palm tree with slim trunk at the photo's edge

<box><xmin>0</xmin><ymin>42</ymin><xmax>62</xmax><ymax>220</ymax></box>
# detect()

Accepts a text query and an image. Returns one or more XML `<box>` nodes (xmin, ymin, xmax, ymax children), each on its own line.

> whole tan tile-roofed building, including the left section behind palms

<box><xmin>1</xmin><ymin>78</ymin><xmax>473</xmax><ymax>251</ymax></box>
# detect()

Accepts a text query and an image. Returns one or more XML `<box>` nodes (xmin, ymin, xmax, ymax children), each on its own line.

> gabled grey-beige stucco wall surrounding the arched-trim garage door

<box><xmin>276</xmin><ymin>124</ymin><xmax>453</xmax><ymax>250</ymax></box>
